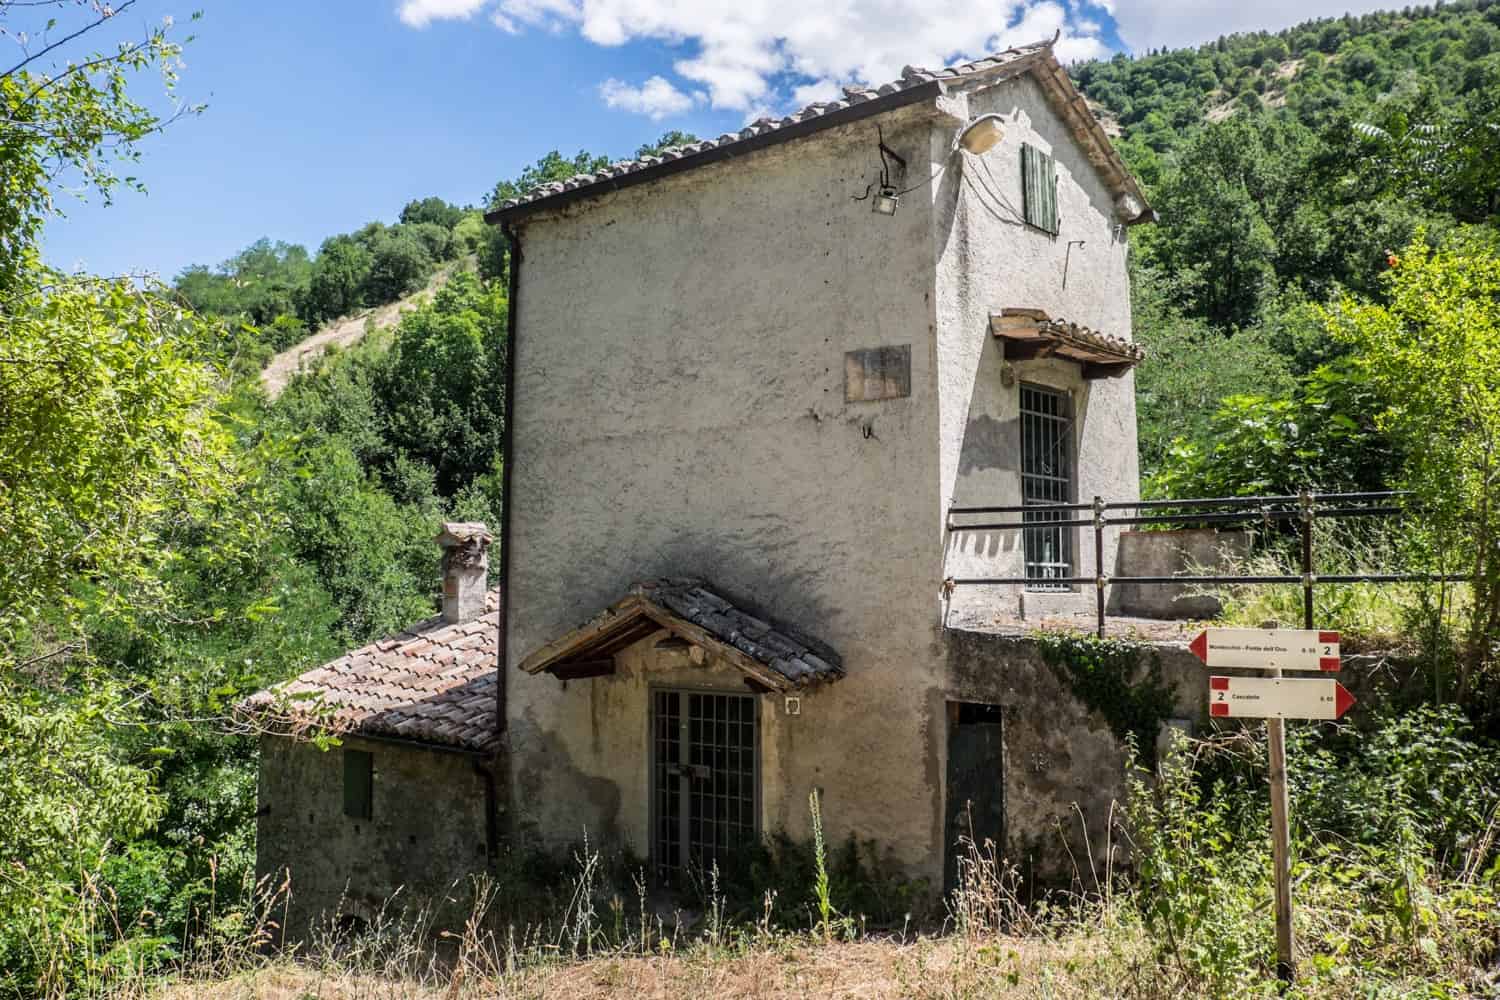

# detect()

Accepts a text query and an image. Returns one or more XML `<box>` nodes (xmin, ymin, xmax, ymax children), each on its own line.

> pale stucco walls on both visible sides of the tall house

<box><xmin>509</xmin><ymin>70</ymin><xmax>1136</xmax><ymax>877</ymax></box>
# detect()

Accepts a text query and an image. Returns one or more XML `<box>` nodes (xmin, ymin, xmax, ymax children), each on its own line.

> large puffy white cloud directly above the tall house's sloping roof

<box><xmin>402</xmin><ymin>0</ymin><xmax>1124</xmax><ymax>117</ymax></box>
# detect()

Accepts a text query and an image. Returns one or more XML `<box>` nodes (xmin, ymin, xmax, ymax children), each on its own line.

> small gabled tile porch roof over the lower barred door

<box><xmin>521</xmin><ymin>579</ymin><xmax>843</xmax><ymax>691</ymax></box>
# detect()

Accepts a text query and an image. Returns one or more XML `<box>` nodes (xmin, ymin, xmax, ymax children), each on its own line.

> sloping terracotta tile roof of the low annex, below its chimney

<box><xmin>239</xmin><ymin>589</ymin><xmax>500</xmax><ymax>753</ymax></box>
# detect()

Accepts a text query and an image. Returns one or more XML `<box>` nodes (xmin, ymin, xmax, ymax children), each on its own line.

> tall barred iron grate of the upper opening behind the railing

<box><xmin>1022</xmin><ymin>382</ymin><xmax>1073</xmax><ymax>591</ymax></box>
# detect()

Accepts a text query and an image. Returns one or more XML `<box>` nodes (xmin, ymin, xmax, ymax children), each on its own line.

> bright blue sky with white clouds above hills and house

<box><xmin>35</xmin><ymin>0</ymin><xmax>1380</xmax><ymax>279</ymax></box>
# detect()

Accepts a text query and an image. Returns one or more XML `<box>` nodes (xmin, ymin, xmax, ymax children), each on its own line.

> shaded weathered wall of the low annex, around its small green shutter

<box><xmin>255</xmin><ymin>736</ymin><xmax>489</xmax><ymax>942</ymax></box>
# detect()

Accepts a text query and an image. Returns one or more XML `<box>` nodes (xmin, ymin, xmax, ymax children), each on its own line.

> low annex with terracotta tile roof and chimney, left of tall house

<box><xmin>240</xmin><ymin>523</ymin><xmax>504</xmax><ymax>940</ymax></box>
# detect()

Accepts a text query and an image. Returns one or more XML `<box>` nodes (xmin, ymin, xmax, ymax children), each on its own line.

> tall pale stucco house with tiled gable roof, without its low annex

<box><xmin>489</xmin><ymin>43</ymin><xmax>1170</xmax><ymax>883</ymax></box>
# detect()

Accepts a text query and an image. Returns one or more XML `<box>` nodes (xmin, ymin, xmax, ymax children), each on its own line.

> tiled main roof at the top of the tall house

<box><xmin>486</xmin><ymin>42</ymin><xmax>1152</xmax><ymax>222</ymax></box>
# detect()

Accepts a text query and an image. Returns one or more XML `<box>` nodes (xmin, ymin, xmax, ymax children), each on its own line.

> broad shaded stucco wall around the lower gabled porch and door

<box><xmin>509</xmin><ymin>109</ymin><xmax>942</xmax><ymax>864</ymax></box>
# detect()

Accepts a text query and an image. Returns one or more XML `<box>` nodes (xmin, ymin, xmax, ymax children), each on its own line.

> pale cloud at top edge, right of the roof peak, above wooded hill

<box><xmin>1116</xmin><ymin>0</ymin><xmax>1398</xmax><ymax>52</ymax></box>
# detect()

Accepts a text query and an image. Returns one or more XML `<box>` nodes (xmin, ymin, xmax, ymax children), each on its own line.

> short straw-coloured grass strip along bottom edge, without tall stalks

<box><xmin>144</xmin><ymin>936</ymin><xmax>1122</xmax><ymax>1000</ymax></box>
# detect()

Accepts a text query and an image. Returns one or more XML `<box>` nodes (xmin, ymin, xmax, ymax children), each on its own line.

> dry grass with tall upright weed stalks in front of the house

<box><xmin>114</xmin><ymin>839</ymin><xmax>1152</xmax><ymax>1000</ymax></box>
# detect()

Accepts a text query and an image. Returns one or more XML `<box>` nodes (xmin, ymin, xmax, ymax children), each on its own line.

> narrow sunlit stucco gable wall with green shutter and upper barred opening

<box><xmin>932</xmin><ymin>76</ymin><xmax>1140</xmax><ymax>621</ymax></box>
